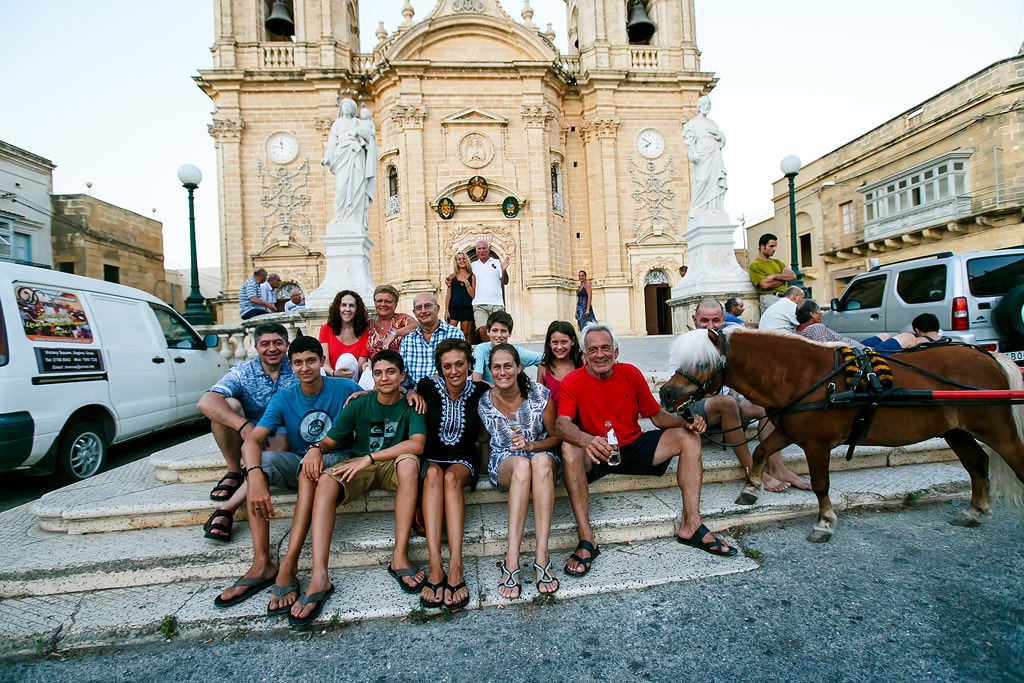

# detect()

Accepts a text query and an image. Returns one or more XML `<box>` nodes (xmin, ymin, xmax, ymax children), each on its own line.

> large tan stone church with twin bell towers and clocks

<box><xmin>196</xmin><ymin>0</ymin><xmax>716</xmax><ymax>339</ymax></box>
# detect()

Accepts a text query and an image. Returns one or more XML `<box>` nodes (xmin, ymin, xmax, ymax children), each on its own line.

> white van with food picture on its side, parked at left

<box><xmin>0</xmin><ymin>262</ymin><xmax>227</xmax><ymax>481</ymax></box>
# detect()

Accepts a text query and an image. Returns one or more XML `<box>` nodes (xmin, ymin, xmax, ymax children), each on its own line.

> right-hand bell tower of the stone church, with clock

<box><xmin>566</xmin><ymin>0</ymin><xmax>716</xmax><ymax>334</ymax></box>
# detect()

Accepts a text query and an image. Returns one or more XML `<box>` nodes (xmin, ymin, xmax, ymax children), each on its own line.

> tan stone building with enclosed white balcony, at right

<box><xmin>746</xmin><ymin>53</ymin><xmax>1024</xmax><ymax>301</ymax></box>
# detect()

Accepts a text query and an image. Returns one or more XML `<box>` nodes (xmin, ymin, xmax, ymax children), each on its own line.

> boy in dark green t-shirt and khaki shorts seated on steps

<box><xmin>288</xmin><ymin>349</ymin><xmax>427</xmax><ymax>626</ymax></box>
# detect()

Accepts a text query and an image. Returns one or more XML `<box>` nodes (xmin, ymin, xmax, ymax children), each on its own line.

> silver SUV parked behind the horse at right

<box><xmin>822</xmin><ymin>247</ymin><xmax>1024</xmax><ymax>367</ymax></box>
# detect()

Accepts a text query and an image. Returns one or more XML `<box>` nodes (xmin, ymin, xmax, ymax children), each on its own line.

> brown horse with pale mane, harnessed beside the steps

<box><xmin>660</xmin><ymin>327</ymin><xmax>1024</xmax><ymax>543</ymax></box>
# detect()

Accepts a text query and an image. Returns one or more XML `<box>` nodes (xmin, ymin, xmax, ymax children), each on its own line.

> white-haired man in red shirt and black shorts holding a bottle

<box><xmin>555</xmin><ymin>323</ymin><xmax>736</xmax><ymax>577</ymax></box>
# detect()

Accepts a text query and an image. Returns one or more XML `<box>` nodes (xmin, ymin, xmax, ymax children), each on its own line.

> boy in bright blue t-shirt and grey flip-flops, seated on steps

<box><xmin>214</xmin><ymin>336</ymin><xmax>359</xmax><ymax>614</ymax></box>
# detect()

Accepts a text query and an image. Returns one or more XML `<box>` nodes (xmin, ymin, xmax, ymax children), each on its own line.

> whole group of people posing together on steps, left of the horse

<box><xmin>200</xmin><ymin>286</ymin><xmax>736</xmax><ymax>626</ymax></box>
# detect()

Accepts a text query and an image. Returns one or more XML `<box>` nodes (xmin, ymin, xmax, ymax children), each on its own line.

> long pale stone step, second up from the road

<box><xmin>0</xmin><ymin>463</ymin><xmax>970</xmax><ymax>598</ymax></box>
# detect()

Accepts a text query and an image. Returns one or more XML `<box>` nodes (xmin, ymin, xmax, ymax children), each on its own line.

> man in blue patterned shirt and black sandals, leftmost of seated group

<box><xmin>197</xmin><ymin>323</ymin><xmax>298</xmax><ymax>541</ymax></box>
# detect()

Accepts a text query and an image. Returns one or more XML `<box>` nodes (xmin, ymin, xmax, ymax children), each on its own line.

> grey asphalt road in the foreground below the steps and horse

<box><xmin>0</xmin><ymin>502</ymin><xmax>1024</xmax><ymax>683</ymax></box>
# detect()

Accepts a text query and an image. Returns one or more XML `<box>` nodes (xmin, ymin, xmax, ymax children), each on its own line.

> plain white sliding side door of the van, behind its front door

<box><xmin>89</xmin><ymin>293</ymin><xmax>175</xmax><ymax>440</ymax></box>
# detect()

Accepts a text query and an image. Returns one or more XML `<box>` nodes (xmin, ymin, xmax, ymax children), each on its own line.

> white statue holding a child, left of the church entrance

<box><xmin>321</xmin><ymin>97</ymin><xmax>377</xmax><ymax>228</ymax></box>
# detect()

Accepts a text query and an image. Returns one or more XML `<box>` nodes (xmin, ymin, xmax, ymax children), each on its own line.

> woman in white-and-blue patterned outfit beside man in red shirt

<box><xmin>479</xmin><ymin>344</ymin><xmax>562</xmax><ymax>600</ymax></box>
